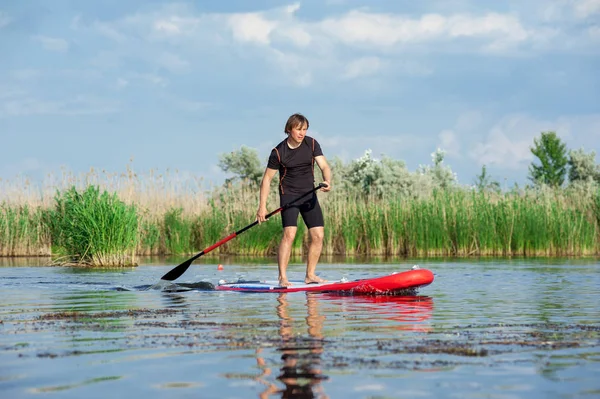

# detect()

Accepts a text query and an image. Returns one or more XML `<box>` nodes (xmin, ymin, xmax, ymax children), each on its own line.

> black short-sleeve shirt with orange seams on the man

<box><xmin>267</xmin><ymin>136</ymin><xmax>323</xmax><ymax>194</ymax></box>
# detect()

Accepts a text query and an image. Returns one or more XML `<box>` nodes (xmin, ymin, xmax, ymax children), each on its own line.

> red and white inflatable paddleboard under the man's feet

<box><xmin>215</xmin><ymin>267</ymin><xmax>433</xmax><ymax>295</ymax></box>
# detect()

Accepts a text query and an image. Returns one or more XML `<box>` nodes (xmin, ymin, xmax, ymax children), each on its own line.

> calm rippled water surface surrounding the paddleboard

<box><xmin>0</xmin><ymin>259</ymin><xmax>600</xmax><ymax>399</ymax></box>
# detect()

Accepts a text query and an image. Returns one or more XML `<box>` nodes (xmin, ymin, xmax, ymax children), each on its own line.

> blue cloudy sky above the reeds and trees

<box><xmin>0</xmin><ymin>0</ymin><xmax>600</xmax><ymax>189</ymax></box>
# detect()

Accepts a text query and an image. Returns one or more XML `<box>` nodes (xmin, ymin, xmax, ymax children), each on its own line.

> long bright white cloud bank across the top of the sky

<box><xmin>70</xmin><ymin>3</ymin><xmax>595</xmax><ymax>86</ymax></box>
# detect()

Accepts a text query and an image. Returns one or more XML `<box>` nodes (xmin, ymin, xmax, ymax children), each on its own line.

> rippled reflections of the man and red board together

<box><xmin>256</xmin><ymin>293</ymin><xmax>433</xmax><ymax>398</ymax></box>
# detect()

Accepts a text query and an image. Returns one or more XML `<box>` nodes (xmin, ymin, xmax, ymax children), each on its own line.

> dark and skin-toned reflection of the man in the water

<box><xmin>257</xmin><ymin>293</ymin><xmax>328</xmax><ymax>398</ymax></box>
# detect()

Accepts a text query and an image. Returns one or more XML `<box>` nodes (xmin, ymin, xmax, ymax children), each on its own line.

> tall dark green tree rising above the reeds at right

<box><xmin>529</xmin><ymin>132</ymin><xmax>568</xmax><ymax>187</ymax></box>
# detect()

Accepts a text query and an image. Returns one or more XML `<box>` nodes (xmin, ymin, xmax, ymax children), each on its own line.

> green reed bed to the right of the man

<box><xmin>324</xmin><ymin>189</ymin><xmax>600</xmax><ymax>256</ymax></box>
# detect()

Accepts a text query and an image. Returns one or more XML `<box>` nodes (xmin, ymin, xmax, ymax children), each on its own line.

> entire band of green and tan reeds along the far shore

<box><xmin>0</xmin><ymin>168</ymin><xmax>600</xmax><ymax>264</ymax></box>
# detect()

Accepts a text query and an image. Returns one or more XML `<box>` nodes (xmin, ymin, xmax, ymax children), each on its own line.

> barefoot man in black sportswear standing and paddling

<box><xmin>256</xmin><ymin>114</ymin><xmax>331</xmax><ymax>287</ymax></box>
